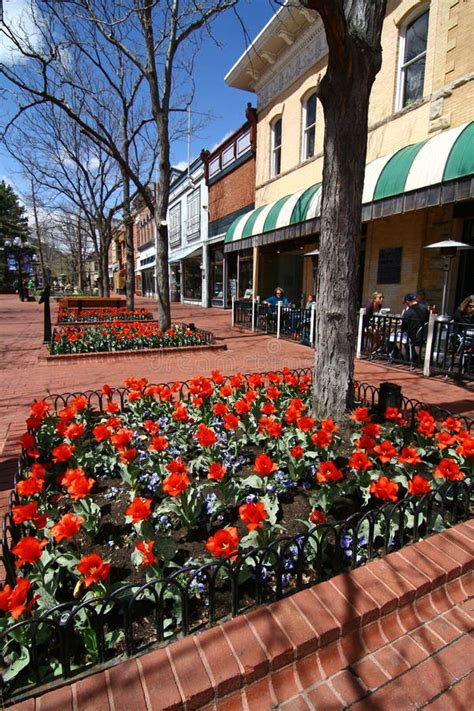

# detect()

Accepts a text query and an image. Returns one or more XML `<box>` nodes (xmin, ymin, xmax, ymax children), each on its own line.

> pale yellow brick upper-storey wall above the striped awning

<box><xmin>255</xmin><ymin>0</ymin><xmax>474</xmax><ymax>206</ymax></box>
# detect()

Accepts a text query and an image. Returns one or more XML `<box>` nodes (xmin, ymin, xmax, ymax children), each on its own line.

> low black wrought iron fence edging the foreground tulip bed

<box><xmin>0</xmin><ymin>369</ymin><xmax>474</xmax><ymax>703</ymax></box>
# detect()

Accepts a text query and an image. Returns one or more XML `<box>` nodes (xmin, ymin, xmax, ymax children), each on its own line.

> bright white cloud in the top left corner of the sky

<box><xmin>0</xmin><ymin>0</ymin><xmax>40</xmax><ymax>64</ymax></box>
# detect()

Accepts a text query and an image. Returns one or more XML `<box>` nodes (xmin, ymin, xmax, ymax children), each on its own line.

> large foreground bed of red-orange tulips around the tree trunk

<box><xmin>0</xmin><ymin>371</ymin><xmax>474</xmax><ymax>700</ymax></box>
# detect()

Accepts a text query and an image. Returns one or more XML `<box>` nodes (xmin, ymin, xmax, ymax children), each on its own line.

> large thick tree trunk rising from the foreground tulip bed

<box><xmin>302</xmin><ymin>0</ymin><xmax>386</xmax><ymax>419</ymax></box>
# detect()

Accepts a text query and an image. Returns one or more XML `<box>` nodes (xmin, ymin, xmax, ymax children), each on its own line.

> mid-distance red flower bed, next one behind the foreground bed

<box><xmin>49</xmin><ymin>321</ymin><xmax>212</xmax><ymax>355</ymax></box>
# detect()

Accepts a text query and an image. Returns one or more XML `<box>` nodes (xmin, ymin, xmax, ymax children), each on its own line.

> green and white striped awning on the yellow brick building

<box><xmin>225</xmin><ymin>121</ymin><xmax>474</xmax><ymax>245</ymax></box>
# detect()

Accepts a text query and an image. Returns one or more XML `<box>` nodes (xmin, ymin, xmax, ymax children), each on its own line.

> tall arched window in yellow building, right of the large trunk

<box><xmin>398</xmin><ymin>10</ymin><xmax>429</xmax><ymax>109</ymax></box>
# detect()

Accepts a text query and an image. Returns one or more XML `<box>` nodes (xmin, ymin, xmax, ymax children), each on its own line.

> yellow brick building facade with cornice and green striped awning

<box><xmin>225</xmin><ymin>0</ymin><xmax>474</xmax><ymax>313</ymax></box>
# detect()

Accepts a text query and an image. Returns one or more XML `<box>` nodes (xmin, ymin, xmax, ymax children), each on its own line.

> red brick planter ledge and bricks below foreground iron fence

<box><xmin>8</xmin><ymin>521</ymin><xmax>474</xmax><ymax>711</ymax></box>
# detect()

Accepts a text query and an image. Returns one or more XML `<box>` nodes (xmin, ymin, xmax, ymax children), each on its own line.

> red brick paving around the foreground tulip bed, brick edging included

<box><xmin>0</xmin><ymin>295</ymin><xmax>474</xmax><ymax>711</ymax></box>
